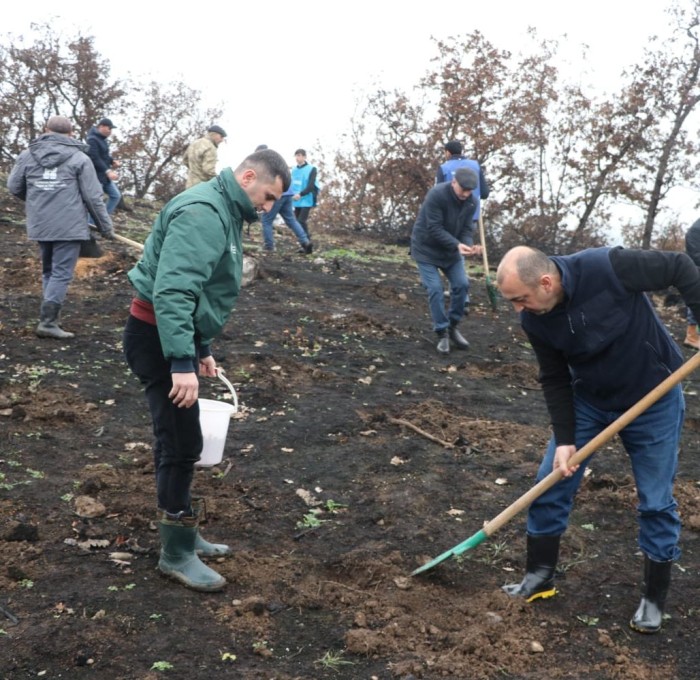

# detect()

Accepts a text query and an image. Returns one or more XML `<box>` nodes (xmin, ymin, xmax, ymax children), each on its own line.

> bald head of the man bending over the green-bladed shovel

<box><xmin>496</xmin><ymin>246</ymin><xmax>564</xmax><ymax>314</ymax></box>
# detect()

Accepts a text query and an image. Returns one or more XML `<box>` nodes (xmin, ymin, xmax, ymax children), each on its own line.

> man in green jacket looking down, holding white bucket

<box><xmin>124</xmin><ymin>149</ymin><xmax>291</xmax><ymax>592</ymax></box>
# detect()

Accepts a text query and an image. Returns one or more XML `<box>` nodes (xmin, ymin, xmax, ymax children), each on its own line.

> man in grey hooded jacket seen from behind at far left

<box><xmin>7</xmin><ymin>116</ymin><xmax>114</xmax><ymax>340</ymax></box>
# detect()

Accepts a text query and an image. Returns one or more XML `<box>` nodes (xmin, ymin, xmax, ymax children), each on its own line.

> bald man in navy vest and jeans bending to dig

<box><xmin>497</xmin><ymin>246</ymin><xmax>700</xmax><ymax>633</ymax></box>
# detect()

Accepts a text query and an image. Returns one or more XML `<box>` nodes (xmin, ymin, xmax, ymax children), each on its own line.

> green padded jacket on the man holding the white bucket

<box><xmin>128</xmin><ymin>168</ymin><xmax>257</xmax><ymax>370</ymax></box>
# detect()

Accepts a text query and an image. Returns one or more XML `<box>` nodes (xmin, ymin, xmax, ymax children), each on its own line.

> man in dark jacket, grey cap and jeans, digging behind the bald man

<box><xmin>411</xmin><ymin>168</ymin><xmax>481</xmax><ymax>354</ymax></box>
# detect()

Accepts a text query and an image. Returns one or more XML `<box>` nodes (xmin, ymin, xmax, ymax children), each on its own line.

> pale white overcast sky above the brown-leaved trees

<box><xmin>0</xmin><ymin>0</ymin><xmax>680</xmax><ymax>170</ymax></box>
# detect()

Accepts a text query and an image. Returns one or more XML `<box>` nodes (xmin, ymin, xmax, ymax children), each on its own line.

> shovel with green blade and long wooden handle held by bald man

<box><xmin>411</xmin><ymin>352</ymin><xmax>700</xmax><ymax>576</ymax></box>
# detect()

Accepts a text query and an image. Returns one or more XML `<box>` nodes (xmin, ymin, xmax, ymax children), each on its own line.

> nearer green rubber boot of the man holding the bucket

<box><xmin>158</xmin><ymin>512</ymin><xmax>226</xmax><ymax>593</ymax></box>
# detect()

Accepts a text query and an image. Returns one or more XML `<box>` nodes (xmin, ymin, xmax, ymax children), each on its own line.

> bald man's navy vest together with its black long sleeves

<box><xmin>521</xmin><ymin>248</ymin><xmax>700</xmax><ymax>445</ymax></box>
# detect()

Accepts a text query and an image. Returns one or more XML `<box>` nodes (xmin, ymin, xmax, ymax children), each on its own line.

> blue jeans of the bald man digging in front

<box><xmin>527</xmin><ymin>386</ymin><xmax>685</xmax><ymax>562</ymax></box>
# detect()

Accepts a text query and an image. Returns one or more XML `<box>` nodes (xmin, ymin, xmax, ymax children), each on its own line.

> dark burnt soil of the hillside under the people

<box><xmin>0</xmin><ymin>193</ymin><xmax>700</xmax><ymax>680</ymax></box>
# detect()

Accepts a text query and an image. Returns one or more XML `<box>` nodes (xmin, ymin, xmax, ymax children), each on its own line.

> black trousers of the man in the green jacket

<box><xmin>124</xmin><ymin>316</ymin><xmax>202</xmax><ymax>514</ymax></box>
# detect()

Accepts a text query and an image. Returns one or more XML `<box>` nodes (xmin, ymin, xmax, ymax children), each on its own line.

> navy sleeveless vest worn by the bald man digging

<box><xmin>520</xmin><ymin>248</ymin><xmax>683</xmax><ymax>411</ymax></box>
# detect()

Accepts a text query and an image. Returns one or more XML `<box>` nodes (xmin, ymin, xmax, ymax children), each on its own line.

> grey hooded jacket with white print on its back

<box><xmin>7</xmin><ymin>132</ymin><xmax>112</xmax><ymax>241</ymax></box>
